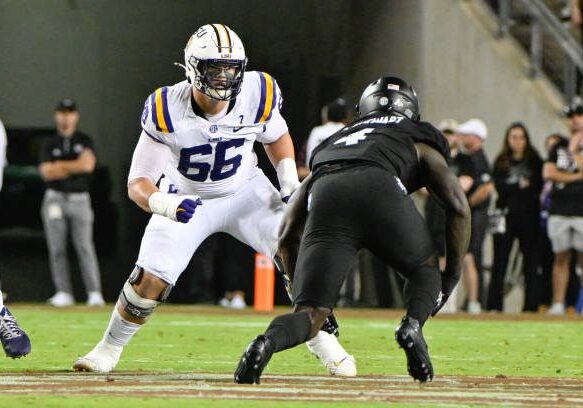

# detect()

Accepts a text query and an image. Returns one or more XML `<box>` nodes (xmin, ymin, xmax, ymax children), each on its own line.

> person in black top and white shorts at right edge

<box><xmin>543</xmin><ymin>100</ymin><xmax>583</xmax><ymax>315</ymax></box>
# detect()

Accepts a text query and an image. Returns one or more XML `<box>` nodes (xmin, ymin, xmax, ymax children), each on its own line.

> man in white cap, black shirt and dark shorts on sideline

<box><xmin>458</xmin><ymin>119</ymin><xmax>494</xmax><ymax>313</ymax></box>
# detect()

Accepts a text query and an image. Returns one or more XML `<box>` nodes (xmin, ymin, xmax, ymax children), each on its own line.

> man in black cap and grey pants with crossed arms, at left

<box><xmin>39</xmin><ymin>99</ymin><xmax>105</xmax><ymax>307</ymax></box>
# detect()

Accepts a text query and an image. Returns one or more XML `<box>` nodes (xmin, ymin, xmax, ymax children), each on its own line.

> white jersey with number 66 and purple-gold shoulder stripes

<box><xmin>142</xmin><ymin>71</ymin><xmax>288</xmax><ymax>199</ymax></box>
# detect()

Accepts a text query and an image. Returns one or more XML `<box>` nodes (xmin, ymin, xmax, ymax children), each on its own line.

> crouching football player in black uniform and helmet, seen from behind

<box><xmin>235</xmin><ymin>77</ymin><xmax>470</xmax><ymax>383</ymax></box>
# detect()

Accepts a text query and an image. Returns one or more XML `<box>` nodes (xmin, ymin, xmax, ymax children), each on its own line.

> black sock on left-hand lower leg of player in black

<box><xmin>265</xmin><ymin>312</ymin><xmax>312</xmax><ymax>353</ymax></box>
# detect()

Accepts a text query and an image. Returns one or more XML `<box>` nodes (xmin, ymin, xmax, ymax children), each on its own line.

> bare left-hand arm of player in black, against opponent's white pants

<box><xmin>277</xmin><ymin>173</ymin><xmax>312</xmax><ymax>279</ymax></box>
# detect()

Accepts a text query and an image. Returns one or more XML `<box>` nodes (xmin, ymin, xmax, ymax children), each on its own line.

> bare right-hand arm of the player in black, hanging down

<box><xmin>415</xmin><ymin>143</ymin><xmax>471</xmax><ymax>296</ymax></box>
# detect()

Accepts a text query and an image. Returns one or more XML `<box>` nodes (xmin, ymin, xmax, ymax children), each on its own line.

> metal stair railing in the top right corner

<box><xmin>498</xmin><ymin>0</ymin><xmax>583</xmax><ymax>102</ymax></box>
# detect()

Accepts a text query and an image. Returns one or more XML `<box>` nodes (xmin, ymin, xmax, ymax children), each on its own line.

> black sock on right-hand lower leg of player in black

<box><xmin>404</xmin><ymin>266</ymin><xmax>441</xmax><ymax>327</ymax></box>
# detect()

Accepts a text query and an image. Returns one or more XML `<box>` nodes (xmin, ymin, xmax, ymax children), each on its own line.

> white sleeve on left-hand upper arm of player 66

<box><xmin>128</xmin><ymin>132</ymin><xmax>170</xmax><ymax>183</ymax></box>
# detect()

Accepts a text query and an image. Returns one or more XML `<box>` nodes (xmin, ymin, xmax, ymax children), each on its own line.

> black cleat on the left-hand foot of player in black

<box><xmin>235</xmin><ymin>334</ymin><xmax>273</xmax><ymax>384</ymax></box>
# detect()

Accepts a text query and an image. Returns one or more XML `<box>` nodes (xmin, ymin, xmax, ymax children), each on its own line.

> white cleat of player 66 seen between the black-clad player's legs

<box><xmin>306</xmin><ymin>330</ymin><xmax>356</xmax><ymax>377</ymax></box>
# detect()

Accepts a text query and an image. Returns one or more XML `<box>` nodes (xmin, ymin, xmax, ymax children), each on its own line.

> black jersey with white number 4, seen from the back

<box><xmin>310</xmin><ymin>113</ymin><xmax>450</xmax><ymax>193</ymax></box>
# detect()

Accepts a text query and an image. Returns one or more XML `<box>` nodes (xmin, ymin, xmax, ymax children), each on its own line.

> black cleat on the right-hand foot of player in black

<box><xmin>395</xmin><ymin>316</ymin><xmax>433</xmax><ymax>382</ymax></box>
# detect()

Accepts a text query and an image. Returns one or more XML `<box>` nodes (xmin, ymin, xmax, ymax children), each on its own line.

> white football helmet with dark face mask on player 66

<box><xmin>184</xmin><ymin>24</ymin><xmax>247</xmax><ymax>101</ymax></box>
